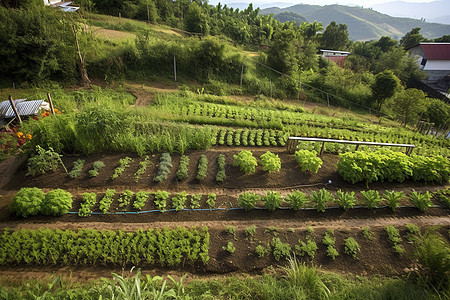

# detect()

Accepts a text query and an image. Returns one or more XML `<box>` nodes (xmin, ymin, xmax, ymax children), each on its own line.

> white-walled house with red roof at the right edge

<box><xmin>408</xmin><ymin>43</ymin><xmax>450</xmax><ymax>98</ymax></box>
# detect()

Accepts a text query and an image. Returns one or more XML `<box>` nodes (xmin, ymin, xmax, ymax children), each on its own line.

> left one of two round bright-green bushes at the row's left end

<box><xmin>9</xmin><ymin>188</ymin><xmax>45</xmax><ymax>218</ymax></box>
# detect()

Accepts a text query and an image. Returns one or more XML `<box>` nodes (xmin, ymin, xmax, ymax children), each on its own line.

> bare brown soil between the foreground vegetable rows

<box><xmin>0</xmin><ymin>147</ymin><xmax>450</xmax><ymax>280</ymax></box>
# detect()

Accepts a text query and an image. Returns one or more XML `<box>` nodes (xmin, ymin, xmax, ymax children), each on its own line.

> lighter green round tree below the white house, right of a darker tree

<box><xmin>392</xmin><ymin>89</ymin><xmax>427</xmax><ymax>126</ymax></box>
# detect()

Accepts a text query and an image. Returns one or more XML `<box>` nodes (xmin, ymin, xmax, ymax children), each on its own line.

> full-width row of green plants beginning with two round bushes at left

<box><xmin>9</xmin><ymin>188</ymin><xmax>450</xmax><ymax>217</ymax></box>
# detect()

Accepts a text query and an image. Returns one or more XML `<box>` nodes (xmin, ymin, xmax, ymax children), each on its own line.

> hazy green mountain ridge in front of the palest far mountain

<box><xmin>260</xmin><ymin>4</ymin><xmax>450</xmax><ymax>41</ymax></box>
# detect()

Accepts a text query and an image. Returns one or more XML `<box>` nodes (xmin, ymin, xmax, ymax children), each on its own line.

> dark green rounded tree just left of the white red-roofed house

<box><xmin>372</xmin><ymin>70</ymin><xmax>400</xmax><ymax>110</ymax></box>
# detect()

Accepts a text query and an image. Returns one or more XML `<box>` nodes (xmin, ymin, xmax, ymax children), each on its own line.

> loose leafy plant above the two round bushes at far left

<box><xmin>27</xmin><ymin>145</ymin><xmax>68</xmax><ymax>176</ymax></box>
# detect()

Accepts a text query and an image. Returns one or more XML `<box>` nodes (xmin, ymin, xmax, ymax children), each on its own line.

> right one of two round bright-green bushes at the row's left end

<box><xmin>41</xmin><ymin>189</ymin><xmax>72</xmax><ymax>216</ymax></box>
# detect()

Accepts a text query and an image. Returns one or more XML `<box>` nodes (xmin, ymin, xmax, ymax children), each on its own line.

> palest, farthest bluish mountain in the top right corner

<box><xmin>371</xmin><ymin>0</ymin><xmax>450</xmax><ymax>24</ymax></box>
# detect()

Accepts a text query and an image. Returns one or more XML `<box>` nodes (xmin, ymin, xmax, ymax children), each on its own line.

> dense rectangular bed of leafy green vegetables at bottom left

<box><xmin>0</xmin><ymin>227</ymin><xmax>209</xmax><ymax>267</ymax></box>
